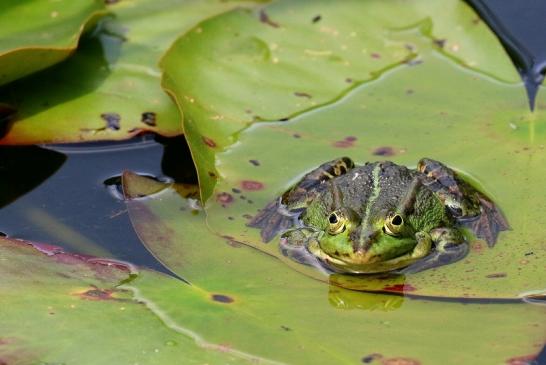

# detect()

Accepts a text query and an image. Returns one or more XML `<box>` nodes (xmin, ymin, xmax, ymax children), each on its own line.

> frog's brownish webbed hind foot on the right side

<box><xmin>459</xmin><ymin>194</ymin><xmax>510</xmax><ymax>247</ymax></box>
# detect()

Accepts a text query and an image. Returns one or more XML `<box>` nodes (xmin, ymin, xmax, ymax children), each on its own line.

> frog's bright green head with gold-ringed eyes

<box><xmin>285</xmin><ymin>176</ymin><xmax>444</xmax><ymax>273</ymax></box>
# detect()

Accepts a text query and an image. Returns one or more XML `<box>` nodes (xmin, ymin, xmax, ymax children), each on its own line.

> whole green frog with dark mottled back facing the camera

<box><xmin>247</xmin><ymin>157</ymin><xmax>509</xmax><ymax>274</ymax></box>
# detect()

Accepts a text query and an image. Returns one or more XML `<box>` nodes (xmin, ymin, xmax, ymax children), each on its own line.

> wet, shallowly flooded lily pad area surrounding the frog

<box><xmin>207</xmin><ymin>42</ymin><xmax>546</xmax><ymax>298</ymax></box>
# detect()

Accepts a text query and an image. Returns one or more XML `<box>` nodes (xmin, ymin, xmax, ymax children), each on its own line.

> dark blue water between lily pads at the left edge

<box><xmin>0</xmin><ymin>135</ymin><xmax>196</xmax><ymax>272</ymax></box>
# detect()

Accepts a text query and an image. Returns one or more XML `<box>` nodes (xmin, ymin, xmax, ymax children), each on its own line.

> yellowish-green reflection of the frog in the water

<box><xmin>328</xmin><ymin>274</ymin><xmax>405</xmax><ymax>312</ymax></box>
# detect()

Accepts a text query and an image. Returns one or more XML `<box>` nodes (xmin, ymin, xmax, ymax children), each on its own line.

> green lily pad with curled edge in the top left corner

<box><xmin>0</xmin><ymin>0</ymin><xmax>105</xmax><ymax>85</ymax></box>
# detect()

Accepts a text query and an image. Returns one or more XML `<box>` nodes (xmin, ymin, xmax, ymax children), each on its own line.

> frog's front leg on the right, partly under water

<box><xmin>398</xmin><ymin>228</ymin><xmax>468</xmax><ymax>274</ymax></box>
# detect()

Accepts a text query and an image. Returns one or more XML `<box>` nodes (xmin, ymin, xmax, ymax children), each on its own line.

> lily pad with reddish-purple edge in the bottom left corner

<box><xmin>0</xmin><ymin>238</ymin><xmax>268</xmax><ymax>364</ymax></box>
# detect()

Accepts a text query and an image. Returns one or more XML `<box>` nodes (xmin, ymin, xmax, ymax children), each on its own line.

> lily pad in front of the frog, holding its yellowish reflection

<box><xmin>120</xmin><ymin>174</ymin><xmax>544</xmax><ymax>364</ymax></box>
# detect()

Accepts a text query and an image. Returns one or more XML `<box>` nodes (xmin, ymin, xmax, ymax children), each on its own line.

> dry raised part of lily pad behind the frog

<box><xmin>161</xmin><ymin>0</ymin><xmax>519</xmax><ymax>199</ymax></box>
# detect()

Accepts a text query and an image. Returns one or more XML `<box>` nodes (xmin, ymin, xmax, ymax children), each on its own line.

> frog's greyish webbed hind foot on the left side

<box><xmin>246</xmin><ymin>198</ymin><xmax>302</xmax><ymax>243</ymax></box>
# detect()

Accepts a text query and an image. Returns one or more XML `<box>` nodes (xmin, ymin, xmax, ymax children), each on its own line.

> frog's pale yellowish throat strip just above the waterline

<box><xmin>307</xmin><ymin>240</ymin><xmax>416</xmax><ymax>274</ymax></box>
